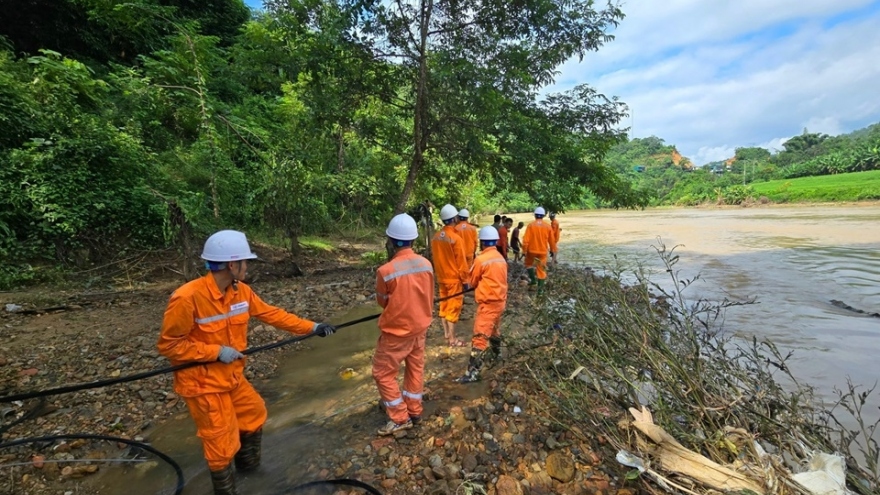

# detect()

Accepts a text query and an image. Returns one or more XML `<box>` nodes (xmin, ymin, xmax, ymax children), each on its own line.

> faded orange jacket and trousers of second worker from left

<box><xmin>373</xmin><ymin>248</ymin><xmax>434</xmax><ymax>424</ymax></box>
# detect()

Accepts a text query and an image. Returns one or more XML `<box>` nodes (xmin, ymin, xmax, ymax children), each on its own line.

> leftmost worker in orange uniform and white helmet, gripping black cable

<box><xmin>158</xmin><ymin>230</ymin><xmax>335</xmax><ymax>495</ymax></box>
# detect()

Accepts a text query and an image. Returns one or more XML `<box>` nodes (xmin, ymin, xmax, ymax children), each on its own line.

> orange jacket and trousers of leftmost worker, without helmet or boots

<box><xmin>158</xmin><ymin>273</ymin><xmax>315</xmax><ymax>471</ymax></box>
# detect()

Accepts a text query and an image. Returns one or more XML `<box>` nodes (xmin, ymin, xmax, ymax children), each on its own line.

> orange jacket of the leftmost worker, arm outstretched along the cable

<box><xmin>158</xmin><ymin>273</ymin><xmax>315</xmax><ymax>397</ymax></box>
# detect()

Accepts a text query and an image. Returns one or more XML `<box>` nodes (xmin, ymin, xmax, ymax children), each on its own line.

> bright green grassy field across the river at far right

<box><xmin>750</xmin><ymin>170</ymin><xmax>880</xmax><ymax>203</ymax></box>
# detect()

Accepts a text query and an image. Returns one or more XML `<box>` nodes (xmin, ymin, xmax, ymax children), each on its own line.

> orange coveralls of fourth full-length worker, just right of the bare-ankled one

<box><xmin>470</xmin><ymin>247</ymin><xmax>507</xmax><ymax>351</ymax></box>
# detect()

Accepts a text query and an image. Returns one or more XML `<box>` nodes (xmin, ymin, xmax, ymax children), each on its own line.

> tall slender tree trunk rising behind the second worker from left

<box><xmin>394</xmin><ymin>0</ymin><xmax>434</xmax><ymax>213</ymax></box>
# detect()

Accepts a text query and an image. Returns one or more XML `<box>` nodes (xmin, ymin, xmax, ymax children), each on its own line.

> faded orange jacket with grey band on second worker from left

<box><xmin>376</xmin><ymin>248</ymin><xmax>434</xmax><ymax>337</ymax></box>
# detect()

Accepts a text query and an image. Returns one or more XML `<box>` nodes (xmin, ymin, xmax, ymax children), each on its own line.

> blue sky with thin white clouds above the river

<box><xmin>245</xmin><ymin>0</ymin><xmax>880</xmax><ymax>165</ymax></box>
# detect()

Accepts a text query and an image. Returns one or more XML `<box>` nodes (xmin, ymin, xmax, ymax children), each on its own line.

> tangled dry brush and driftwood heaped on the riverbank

<box><xmin>518</xmin><ymin>244</ymin><xmax>880</xmax><ymax>495</ymax></box>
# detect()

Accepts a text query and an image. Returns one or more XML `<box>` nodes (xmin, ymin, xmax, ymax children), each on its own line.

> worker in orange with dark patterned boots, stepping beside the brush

<box><xmin>458</xmin><ymin>226</ymin><xmax>507</xmax><ymax>383</ymax></box>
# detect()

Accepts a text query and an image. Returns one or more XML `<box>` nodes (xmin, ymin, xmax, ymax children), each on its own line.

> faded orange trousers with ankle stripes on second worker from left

<box><xmin>373</xmin><ymin>332</ymin><xmax>427</xmax><ymax>424</ymax></box>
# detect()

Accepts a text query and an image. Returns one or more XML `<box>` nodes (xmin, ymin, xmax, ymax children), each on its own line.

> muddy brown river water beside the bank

<box><xmin>560</xmin><ymin>205</ymin><xmax>880</xmax><ymax>426</ymax></box>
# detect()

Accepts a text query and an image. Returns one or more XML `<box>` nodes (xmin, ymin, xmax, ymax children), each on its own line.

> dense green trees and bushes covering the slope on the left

<box><xmin>0</xmin><ymin>0</ymin><xmax>643</xmax><ymax>285</ymax></box>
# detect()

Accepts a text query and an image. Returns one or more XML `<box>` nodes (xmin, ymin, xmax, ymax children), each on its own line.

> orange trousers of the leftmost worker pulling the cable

<box><xmin>183</xmin><ymin>378</ymin><xmax>266</xmax><ymax>471</ymax></box>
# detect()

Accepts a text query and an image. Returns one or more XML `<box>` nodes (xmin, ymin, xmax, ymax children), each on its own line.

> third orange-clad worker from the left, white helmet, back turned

<box><xmin>431</xmin><ymin>205</ymin><xmax>470</xmax><ymax>347</ymax></box>
